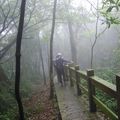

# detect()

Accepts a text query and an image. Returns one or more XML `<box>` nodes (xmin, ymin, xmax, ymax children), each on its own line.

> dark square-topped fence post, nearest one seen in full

<box><xmin>87</xmin><ymin>69</ymin><xmax>96</xmax><ymax>112</ymax></box>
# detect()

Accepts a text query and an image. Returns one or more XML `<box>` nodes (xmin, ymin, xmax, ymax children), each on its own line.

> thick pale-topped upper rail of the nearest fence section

<box><xmin>90</xmin><ymin>76</ymin><xmax>117</xmax><ymax>98</ymax></box>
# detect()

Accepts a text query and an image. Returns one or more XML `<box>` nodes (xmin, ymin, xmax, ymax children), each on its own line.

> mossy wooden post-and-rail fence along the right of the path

<box><xmin>54</xmin><ymin>64</ymin><xmax>120</xmax><ymax>120</ymax></box>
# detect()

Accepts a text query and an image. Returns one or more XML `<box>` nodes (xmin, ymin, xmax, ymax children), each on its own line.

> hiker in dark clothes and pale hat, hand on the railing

<box><xmin>54</xmin><ymin>53</ymin><xmax>70</xmax><ymax>86</ymax></box>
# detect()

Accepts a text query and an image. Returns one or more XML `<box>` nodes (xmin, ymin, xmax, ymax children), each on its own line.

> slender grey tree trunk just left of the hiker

<box><xmin>49</xmin><ymin>0</ymin><xmax>57</xmax><ymax>99</ymax></box>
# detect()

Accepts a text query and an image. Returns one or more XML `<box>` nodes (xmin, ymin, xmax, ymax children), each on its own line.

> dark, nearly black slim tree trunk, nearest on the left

<box><xmin>15</xmin><ymin>0</ymin><xmax>26</xmax><ymax>120</ymax></box>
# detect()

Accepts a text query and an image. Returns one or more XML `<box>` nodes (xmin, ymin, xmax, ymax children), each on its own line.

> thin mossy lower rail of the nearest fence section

<box><xmin>93</xmin><ymin>96</ymin><xmax>118</xmax><ymax>120</ymax></box>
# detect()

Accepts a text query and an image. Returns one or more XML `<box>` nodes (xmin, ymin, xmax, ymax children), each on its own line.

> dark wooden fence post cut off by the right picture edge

<box><xmin>116</xmin><ymin>75</ymin><xmax>120</xmax><ymax>120</ymax></box>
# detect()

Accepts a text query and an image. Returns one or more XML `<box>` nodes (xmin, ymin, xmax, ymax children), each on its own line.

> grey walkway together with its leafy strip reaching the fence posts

<box><xmin>54</xmin><ymin>79</ymin><xmax>105</xmax><ymax>120</ymax></box>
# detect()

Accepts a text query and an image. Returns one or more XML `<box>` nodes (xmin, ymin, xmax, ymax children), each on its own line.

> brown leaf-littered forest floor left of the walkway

<box><xmin>24</xmin><ymin>85</ymin><xmax>58</xmax><ymax>120</ymax></box>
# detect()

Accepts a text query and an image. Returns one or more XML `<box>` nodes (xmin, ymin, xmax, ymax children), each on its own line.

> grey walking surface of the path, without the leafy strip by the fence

<box><xmin>55</xmin><ymin>85</ymin><xmax>86</xmax><ymax>120</ymax></box>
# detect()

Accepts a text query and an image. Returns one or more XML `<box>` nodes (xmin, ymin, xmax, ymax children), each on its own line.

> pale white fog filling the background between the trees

<box><xmin>0</xmin><ymin>0</ymin><xmax>119</xmax><ymax>81</ymax></box>
